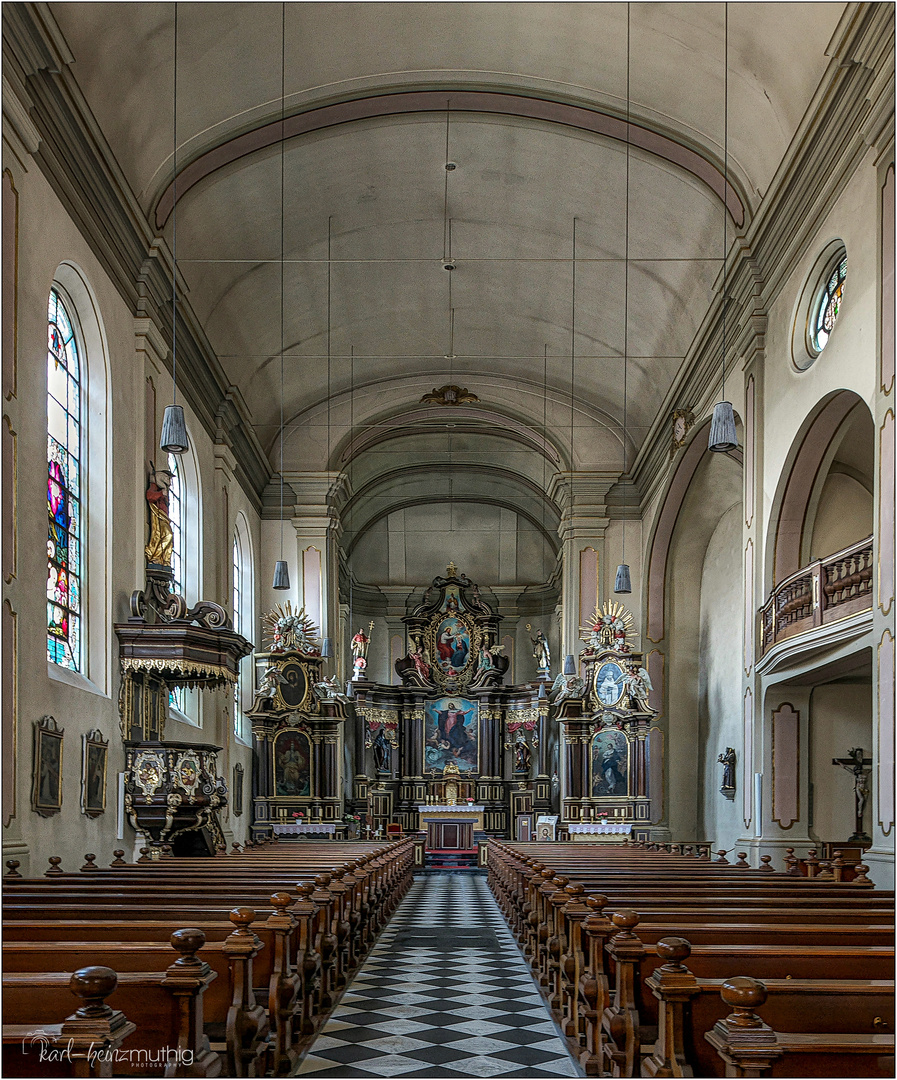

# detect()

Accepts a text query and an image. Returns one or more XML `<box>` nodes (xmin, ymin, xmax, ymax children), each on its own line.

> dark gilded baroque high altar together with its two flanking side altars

<box><xmin>235</xmin><ymin>566</ymin><xmax>663</xmax><ymax>849</ymax></box>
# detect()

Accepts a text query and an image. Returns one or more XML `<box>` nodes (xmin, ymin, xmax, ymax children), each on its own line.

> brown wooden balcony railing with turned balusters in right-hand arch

<box><xmin>760</xmin><ymin>537</ymin><xmax>872</xmax><ymax>654</ymax></box>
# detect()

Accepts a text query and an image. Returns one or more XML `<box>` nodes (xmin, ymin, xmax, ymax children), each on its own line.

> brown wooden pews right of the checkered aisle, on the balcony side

<box><xmin>488</xmin><ymin>840</ymin><xmax>895</xmax><ymax>1077</ymax></box>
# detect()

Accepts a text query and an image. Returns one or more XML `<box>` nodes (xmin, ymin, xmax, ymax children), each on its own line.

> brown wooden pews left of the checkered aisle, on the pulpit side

<box><xmin>2</xmin><ymin>840</ymin><xmax>413</xmax><ymax>1077</ymax></box>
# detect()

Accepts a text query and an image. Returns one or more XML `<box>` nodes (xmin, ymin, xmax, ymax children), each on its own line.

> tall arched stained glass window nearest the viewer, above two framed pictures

<box><xmin>46</xmin><ymin>288</ymin><xmax>84</xmax><ymax>672</ymax></box>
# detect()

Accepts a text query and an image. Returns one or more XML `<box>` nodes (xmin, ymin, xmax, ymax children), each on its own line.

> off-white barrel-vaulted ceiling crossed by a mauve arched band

<box><xmin>50</xmin><ymin>3</ymin><xmax>845</xmax><ymax>548</ymax></box>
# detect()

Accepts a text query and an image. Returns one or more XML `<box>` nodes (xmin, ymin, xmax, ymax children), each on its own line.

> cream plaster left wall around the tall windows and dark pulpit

<box><xmin>3</xmin><ymin>145</ymin><xmax>259</xmax><ymax>874</ymax></box>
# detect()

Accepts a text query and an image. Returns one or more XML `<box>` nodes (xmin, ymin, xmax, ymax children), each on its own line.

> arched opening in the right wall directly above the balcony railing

<box><xmin>765</xmin><ymin>390</ymin><xmax>873</xmax><ymax>592</ymax></box>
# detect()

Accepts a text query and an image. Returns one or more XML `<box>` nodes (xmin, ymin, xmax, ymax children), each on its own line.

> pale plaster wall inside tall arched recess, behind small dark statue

<box><xmin>697</xmin><ymin>503</ymin><xmax>744</xmax><ymax>850</ymax></box>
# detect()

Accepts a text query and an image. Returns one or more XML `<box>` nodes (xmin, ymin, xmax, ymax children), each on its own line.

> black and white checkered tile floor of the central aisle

<box><xmin>294</xmin><ymin>873</ymin><xmax>583</xmax><ymax>1080</ymax></box>
